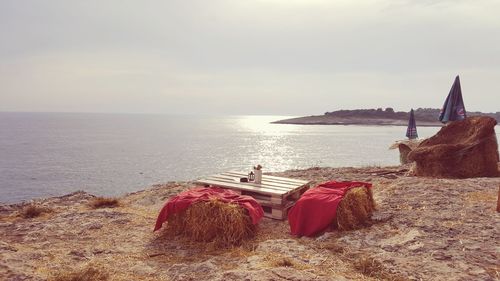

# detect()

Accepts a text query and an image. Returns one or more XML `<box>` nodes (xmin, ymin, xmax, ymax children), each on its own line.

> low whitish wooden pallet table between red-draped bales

<box><xmin>196</xmin><ymin>171</ymin><xmax>309</xmax><ymax>220</ymax></box>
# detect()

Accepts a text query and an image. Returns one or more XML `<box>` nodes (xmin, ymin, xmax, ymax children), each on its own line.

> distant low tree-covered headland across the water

<box><xmin>272</xmin><ymin>107</ymin><xmax>500</xmax><ymax>126</ymax></box>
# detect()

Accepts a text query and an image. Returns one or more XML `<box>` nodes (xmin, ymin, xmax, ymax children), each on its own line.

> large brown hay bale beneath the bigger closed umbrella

<box><xmin>408</xmin><ymin>116</ymin><xmax>499</xmax><ymax>178</ymax></box>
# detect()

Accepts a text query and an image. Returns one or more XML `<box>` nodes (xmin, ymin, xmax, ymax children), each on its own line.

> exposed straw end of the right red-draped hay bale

<box><xmin>335</xmin><ymin>187</ymin><xmax>375</xmax><ymax>230</ymax></box>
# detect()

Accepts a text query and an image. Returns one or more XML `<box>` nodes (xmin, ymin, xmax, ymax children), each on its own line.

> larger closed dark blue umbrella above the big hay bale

<box><xmin>439</xmin><ymin>75</ymin><xmax>466</xmax><ymax>123</ymax></box>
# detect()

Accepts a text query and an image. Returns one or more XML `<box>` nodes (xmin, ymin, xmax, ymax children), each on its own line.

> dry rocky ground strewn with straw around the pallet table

<box><xmin>0</xmin><ymin>167</ymin><xmax>500</xmax><ymax>280</ymax></box>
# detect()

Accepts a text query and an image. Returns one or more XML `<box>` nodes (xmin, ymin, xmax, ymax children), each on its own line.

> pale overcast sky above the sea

<box><xmin>0</xmin><ymin>0</ymin><xmax>500</xmax><ymax>116</ymax></box>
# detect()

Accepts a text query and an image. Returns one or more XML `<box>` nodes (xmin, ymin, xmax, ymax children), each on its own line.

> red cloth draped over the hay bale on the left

<box><xmin>153</xmin><ymin>187</ymin><xmax>264</xmax><ymax>231</ymax></box>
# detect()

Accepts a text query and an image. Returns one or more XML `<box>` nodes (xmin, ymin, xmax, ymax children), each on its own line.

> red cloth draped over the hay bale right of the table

<box><xmin>288</xmin><ymin>181</ymin><xmax>372</xmax><ymax>237</ymax></box>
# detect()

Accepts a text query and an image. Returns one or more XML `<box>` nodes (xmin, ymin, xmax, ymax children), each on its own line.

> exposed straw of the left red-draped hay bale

<box><xmin>166</xmin><ymin>199</ymin><xmax>257</xmax><ymax>247</ymax></box>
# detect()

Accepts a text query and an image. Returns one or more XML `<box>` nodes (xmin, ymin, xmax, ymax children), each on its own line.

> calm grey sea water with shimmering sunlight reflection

<box><xmin>0</xmin><ymin>113</ymin><xmax>496</xmax><ymax>203</ymax></box>
